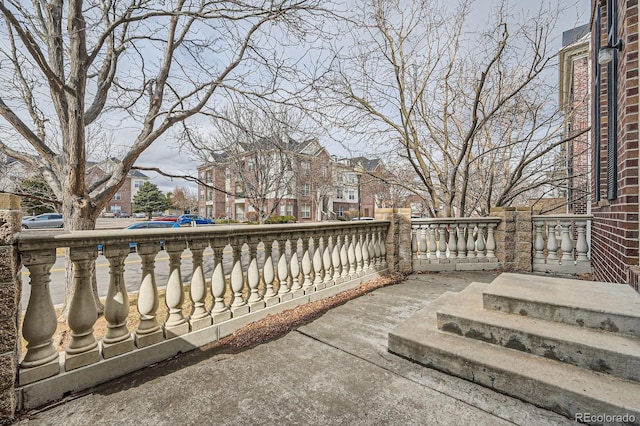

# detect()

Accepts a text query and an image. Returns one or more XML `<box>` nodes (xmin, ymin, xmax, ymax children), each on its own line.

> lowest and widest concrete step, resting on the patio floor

<box><xmin>388</xmin><ymin>294</ymin><xmax>640</xmax><ymax>424</ymax></box>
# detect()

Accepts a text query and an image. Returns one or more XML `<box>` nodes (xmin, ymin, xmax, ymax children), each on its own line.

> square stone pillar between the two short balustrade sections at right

<box><xmin>490</xmin><ymin>207</ymin><xmax>534</xmax><ymax>272</ymax></box>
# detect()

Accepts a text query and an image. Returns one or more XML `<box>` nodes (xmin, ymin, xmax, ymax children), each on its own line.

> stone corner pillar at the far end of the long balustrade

<box><xmin>376</xmin><ymin>209</ymin><xmax>412</xmax><ymax>273</ymax></box>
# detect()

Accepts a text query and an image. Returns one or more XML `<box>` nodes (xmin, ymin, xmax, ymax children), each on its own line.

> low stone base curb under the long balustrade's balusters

<box><xmin>12</xmin><ymin>269</ymin><xmax>389</xmax><ymax>412</ymax></box>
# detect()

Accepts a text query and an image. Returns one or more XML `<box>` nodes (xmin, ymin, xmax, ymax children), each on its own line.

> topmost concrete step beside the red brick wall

<box><xmin>483</xmin><ymin>273</ymin><xmax>640</xmax><ymax>337</ymax></box>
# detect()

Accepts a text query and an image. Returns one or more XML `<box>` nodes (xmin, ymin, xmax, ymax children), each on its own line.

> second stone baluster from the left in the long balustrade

<box><xmin>64</xmin><ymin>247</ymin><xmax>100</xmax><ymax>371</ymax></box>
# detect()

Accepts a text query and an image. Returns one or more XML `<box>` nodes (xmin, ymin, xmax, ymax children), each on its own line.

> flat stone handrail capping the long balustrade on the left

<box><xmin>15</xmin><ymin>220</ymin><xmax>390</xmax><ymax>250</ymax></box>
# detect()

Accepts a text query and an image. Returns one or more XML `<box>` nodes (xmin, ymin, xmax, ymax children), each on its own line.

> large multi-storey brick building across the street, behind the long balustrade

<box><xmin>198</xmin><ymin>139</ymin><xmax>382</xmax><ymax>222</ymax></box>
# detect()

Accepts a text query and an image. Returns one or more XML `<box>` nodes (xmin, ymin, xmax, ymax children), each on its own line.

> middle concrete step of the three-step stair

<box><xmin>437</xmin><ymin>283</ymin><xmax>640</xmax><ymax>382</ymax></box>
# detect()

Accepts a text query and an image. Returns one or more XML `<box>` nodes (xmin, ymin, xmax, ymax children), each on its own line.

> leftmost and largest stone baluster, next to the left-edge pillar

<box><xmin>19</xmin><ymin>249</ymin><xmax>60</xmax><ymax>385</ymax></box>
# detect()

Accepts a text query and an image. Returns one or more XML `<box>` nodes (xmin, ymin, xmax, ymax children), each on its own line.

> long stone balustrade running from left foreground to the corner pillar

<box><xmin>18</xmin><ymin>221</ymin><xmax>389</xmax><ymax>400</ymax></box>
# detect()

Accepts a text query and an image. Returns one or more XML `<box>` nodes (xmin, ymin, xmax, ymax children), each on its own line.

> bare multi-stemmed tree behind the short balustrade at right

<box><xmin>325</xmin><ymin>0</ymin><xmax>588</xmax><ymax>216</ymax></box>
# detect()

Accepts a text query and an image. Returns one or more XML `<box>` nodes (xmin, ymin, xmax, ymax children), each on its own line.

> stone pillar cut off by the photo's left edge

<box><xmin>0</xmin><ymin>193</ymin><xmax>22</xmax><ymax>424</ymax></box>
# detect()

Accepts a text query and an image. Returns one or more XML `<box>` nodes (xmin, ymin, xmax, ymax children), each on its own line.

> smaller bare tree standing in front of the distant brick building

<box><xmin>185</xmin><ymin>102</ymin><xmax>318</xmax><ymax>223</ymax></box>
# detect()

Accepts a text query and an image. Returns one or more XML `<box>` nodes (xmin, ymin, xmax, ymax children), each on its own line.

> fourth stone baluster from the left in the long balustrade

<box><xmin>134</xmin><ymin>243</ymin><xmax>164</xmax><ymax>348</ymax></box>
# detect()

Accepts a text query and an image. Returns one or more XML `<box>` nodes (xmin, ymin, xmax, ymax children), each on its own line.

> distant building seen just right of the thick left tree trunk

<box><xmin>87</xmin><ymin>158</ymin><xmax>149</xmax><ymax>215</ymax></box>
